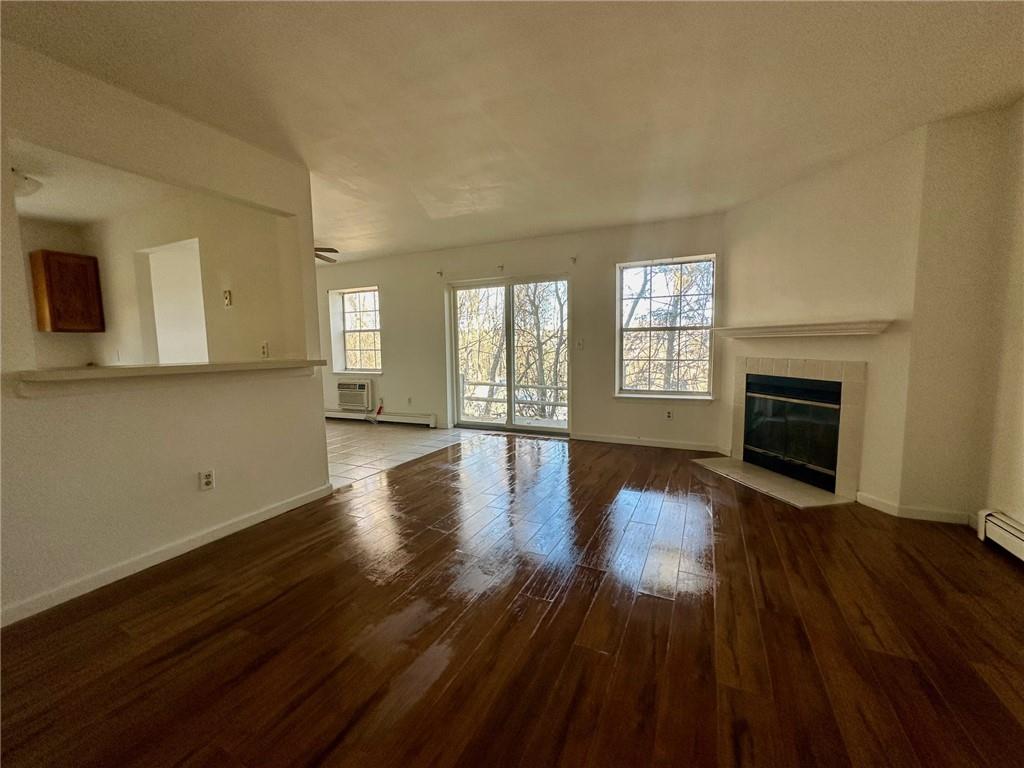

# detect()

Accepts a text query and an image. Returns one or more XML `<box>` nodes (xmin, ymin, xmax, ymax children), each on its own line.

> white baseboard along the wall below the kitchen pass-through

<box><xmin>0</xmin><ymin>484</ymin><xmax>334</xmax><ymax>627</ymax></box>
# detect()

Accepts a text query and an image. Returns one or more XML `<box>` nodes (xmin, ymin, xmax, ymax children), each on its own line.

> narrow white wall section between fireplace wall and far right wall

<box><xmin>900</xmin><ymin>110</ymin><xmax>1020</xmax><ymax>516</ymax></box>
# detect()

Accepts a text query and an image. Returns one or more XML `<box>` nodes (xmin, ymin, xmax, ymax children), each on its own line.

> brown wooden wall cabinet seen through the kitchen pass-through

<box><xmin>29</xmin><ymin>251</ymin><xmax>105</xmax><ymax>333</ymax></box>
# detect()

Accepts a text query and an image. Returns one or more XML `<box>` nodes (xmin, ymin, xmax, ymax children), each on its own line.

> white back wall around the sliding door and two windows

<box><xmin>316</xmin><ymin>216</ymin><xmax>723</xmax><ymax>450</ymax></box>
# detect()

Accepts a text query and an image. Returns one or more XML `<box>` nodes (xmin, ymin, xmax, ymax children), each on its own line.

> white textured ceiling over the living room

<box><xmin>0</xmin><ymin>2</ymin><xmax>1024</xmax><ymax>258</ymax></box>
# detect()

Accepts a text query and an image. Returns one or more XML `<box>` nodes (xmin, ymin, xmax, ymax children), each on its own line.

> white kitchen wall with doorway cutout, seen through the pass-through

<box><xmin>83</xmin><ymin>190</ymin><xmax>305</xmax><ymax>365</ymax></box>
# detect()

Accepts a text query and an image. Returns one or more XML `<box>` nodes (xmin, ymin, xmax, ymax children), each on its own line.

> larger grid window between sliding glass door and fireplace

<box><xmin>616</xmin><ymin>255</ymin><xmax>715</xmax><ymax>397</ymax></box>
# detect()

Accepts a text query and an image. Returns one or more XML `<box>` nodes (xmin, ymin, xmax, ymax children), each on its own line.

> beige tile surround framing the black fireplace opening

<box><xmin>732</xmin><ymin>357</ymin><xmax>867</xmax><ymax>500</ymax></box>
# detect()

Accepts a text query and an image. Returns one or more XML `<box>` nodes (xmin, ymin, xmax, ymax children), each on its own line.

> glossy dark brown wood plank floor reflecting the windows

<box><xmin>2</xmin><ymin>434</ymin><xmax>1024</xmax><ymax>768</ymax></box>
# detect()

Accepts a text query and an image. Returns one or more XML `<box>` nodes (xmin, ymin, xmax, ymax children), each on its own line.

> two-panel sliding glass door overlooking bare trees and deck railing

<box><xmin>454</xmin><ymin>280</ymin><xmax>569</xmax><ymax>431</ymax></box>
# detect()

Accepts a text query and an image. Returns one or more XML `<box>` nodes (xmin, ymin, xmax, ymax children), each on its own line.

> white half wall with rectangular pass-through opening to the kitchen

<box><xmin>0</xmin><ymin>41</ymin><xmax>330</xmax><ymax>622</ymax></box>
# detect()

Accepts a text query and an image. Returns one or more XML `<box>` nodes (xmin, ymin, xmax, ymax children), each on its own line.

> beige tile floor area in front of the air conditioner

<box><xmin>327</xmin><ymin>419</ymin><xmax>480</xmax><ymax>486</ymax></box>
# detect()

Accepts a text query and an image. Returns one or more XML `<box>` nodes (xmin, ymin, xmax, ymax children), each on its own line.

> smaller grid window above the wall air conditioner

<box><xmin>329</xmin><ymin>288</ymin><xmax>381</xmax><ymax>373</ymax></box>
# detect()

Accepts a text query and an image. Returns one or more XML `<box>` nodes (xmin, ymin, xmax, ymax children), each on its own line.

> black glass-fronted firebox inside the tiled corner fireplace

<box><xmin>743</xmin><ymin>374</ymin><xmax>843</xmax><ymax>493</ymax></box>
